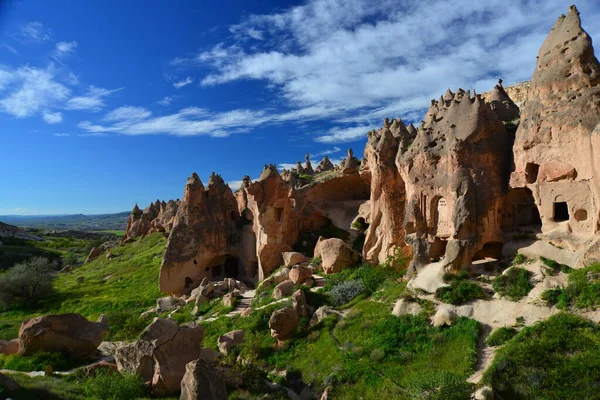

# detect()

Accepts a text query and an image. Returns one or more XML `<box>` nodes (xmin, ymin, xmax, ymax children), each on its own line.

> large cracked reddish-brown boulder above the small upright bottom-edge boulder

<box><xmin>115</xmin><ymin>318</ymin><xmax>204</xmax><ymax>396</ymax></box>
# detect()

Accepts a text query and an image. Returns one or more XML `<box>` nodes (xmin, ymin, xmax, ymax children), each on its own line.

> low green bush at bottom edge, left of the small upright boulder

<box><xmin>84</xmin><ymin>370</ymin><xmax>146</xmax><ymax>400</ymax></box>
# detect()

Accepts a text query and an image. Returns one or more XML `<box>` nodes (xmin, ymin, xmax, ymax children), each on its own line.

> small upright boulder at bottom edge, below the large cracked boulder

<box><xmin>179</xmin><ymin>360</ymin><xmax>227</xmax><ymax>400</ymax></box>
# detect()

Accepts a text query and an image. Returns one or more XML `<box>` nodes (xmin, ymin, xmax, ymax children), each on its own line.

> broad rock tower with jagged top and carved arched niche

<box><xmin>396</xmin><ymin>90</ymin><xmax>510</xmax><ymax>269</ymax></box>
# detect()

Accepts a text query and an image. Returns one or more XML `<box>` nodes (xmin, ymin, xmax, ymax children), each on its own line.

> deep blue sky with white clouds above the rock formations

<box><xmin>0</xmin><ymin>0</ymin><xmax>600</xmax><ymax>215</ymax></box>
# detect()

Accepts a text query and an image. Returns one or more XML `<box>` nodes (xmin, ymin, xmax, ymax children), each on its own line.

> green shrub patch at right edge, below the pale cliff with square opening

<box><xmin>542</xmin><ymin>263</ymin><xmax>600</xmax><ymax>310</ymax></box>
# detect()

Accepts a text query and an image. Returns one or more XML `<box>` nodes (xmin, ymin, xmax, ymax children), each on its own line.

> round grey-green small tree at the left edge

<box><xmin>0</xmin><ymin>257</ymin><xmax>55</xmax><ymax>308</ymax></box>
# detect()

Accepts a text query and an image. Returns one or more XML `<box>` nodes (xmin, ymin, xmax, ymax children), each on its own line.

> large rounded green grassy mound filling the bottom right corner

<box><xmin>483</xmin><ymin>313</ymin><xmax>600</xmax><ymax>400</ymax></box>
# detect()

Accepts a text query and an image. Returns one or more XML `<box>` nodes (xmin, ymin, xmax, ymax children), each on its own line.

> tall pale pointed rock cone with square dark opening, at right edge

<box><xmin>510</xmin><ymin>6</ymin><xmax>600</xmax><ymax>235</ymax></box>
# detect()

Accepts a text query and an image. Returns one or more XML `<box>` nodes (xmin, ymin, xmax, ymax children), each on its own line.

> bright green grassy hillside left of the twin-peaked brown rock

<box><xmin>0</xmin><ymin>233</ymin><xmax>166</xmax><ymax>340</ymax></box>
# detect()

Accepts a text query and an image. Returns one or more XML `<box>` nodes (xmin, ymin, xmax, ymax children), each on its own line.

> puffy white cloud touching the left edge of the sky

<box><xmin>0</xmin><ymin>66</ymin><xmax>71</xmax><ymax>119</ymax></box>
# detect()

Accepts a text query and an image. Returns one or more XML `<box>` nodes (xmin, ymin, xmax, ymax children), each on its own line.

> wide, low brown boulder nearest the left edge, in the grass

<box><xmin>19</xmin><ymin>314</ymin><xmax>108</xmax><ymax>358</ymax></box>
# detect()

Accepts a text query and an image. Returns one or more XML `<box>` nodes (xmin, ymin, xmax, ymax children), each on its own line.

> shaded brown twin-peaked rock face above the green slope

<box><xmin>160</xmin><ymin>174</ymin><xmax>247</xmax><ymax>293</ymax></box>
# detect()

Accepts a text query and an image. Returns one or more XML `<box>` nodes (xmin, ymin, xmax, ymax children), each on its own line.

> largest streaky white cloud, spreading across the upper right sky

<box><xmin>177</xmin><ymin>0</ymin><xmax>600</xmax><ymax>143</ymax></box>
